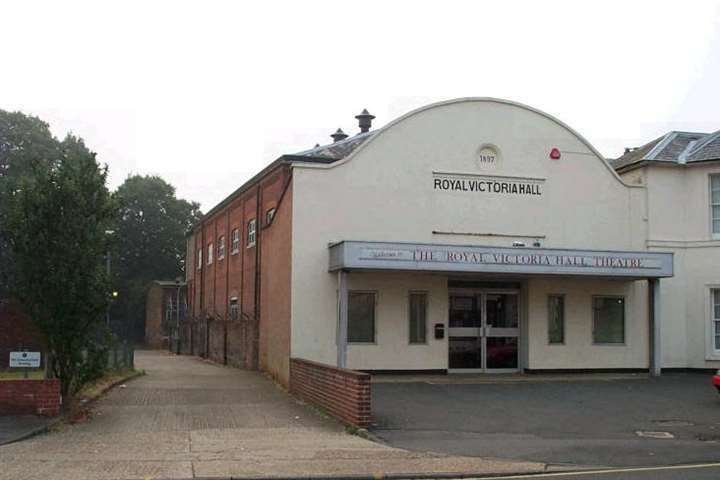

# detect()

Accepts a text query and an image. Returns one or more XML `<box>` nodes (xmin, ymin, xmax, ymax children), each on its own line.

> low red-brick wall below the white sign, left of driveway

<box><xmin>0</xmin><ymin>378</ymin><xmax>61</xmax><ymax>417</ymax></box>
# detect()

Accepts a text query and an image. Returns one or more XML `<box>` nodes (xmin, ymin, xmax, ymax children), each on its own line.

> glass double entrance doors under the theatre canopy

<box><xmin>448</xmin><ymin>290</ymin><xmax>520</xmax><ymax>372</ymax></box>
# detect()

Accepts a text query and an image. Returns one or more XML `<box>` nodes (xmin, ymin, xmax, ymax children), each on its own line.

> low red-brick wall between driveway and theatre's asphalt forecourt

<box><xmin>290</xmin><ymin>358</ymin><xmax>371</xmax><ymax>428</ymax></box>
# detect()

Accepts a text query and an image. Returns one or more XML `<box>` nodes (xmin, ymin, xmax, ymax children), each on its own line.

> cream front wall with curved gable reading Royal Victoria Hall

<box><xmin>291</xmin><ymin>99</ymin><xmax>647</xmax><ymax>369</ymax></box>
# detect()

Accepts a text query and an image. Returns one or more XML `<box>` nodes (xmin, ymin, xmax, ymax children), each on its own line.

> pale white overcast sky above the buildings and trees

<box><xmin>0</xmin><ymin>0</ymin><xmax>720</xmax><ymax>211</ymax></box>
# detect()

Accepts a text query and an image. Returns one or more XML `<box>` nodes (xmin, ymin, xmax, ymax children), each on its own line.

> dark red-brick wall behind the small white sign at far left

<box><xmin>0</xmin><ymin>300</ymin><xmax>45</xmax><ymax>371</ymax></box>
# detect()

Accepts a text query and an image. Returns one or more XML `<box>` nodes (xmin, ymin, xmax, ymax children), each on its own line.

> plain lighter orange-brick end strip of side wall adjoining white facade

<box><xmin>259</xmin><ymin>185</ymin><xmax>292</xmax><ymax>387</ymax></box>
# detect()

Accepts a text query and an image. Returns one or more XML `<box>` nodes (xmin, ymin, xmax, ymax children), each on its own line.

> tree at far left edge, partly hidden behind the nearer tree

<box><xmin>0</xmin><ymin>110</ymin><xmax>60</xmax><ymax>299</ymax></box>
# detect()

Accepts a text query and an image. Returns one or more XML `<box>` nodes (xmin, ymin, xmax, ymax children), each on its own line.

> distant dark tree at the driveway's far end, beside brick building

<box><xmin>112</xmin><ymin>175</ymin><xmax>202</xmax><ymax>341</ymax></box>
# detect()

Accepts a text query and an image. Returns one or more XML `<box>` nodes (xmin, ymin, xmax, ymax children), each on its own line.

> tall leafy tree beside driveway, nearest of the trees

<box><xmin>5</xmin><ymin>132</ymin><xmax>115</xmax><ymax>397</ymax></box>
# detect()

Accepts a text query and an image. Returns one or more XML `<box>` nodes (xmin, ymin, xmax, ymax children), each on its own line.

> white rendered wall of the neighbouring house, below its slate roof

<box><xmin>623</xmin><ymin>164</ymin><xmax>720</xmax><ymax>368</ymax></box>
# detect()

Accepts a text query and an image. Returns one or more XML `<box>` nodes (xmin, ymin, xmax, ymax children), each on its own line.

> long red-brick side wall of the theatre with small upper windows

<box><xmin>180</xmin><ymin>166</ymin><xmax>292</xmax><ymax>372</ymax></box>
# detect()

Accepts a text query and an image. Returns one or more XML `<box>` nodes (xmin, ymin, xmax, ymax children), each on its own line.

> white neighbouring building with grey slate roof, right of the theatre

<box><xmin>611</xmin><ymin>131</ymin><xmax>720</xmax><ymax>368</ymax></box>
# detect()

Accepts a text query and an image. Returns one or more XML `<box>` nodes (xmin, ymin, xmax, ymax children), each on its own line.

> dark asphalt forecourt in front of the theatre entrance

<box><xmin>371</xmin><ymin>374</ymin><xmax>720</xmax><ymax>468</ymax></box>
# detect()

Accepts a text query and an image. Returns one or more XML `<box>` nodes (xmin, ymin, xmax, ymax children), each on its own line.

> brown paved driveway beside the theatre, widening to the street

<box><xmin>0</xmin><ymin>351</ymin><xmax>545</xmax><ymax>480</ymax></box>
